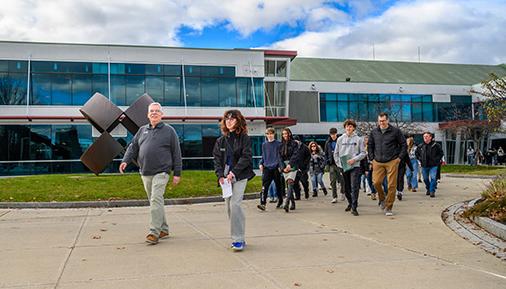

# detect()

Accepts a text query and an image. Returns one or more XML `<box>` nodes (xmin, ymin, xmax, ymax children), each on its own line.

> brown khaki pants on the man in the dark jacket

<box><xmin>372</xmin><ymin>158</ymin><xmax>400</xmax><ymax>210</ymax></box>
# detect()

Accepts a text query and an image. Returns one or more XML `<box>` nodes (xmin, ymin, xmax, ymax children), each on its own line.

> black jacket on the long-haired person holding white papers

<box><xmin>213</xmin><ymin>134</ymin><xmax>255</xmax><ymax>181</ymax></box>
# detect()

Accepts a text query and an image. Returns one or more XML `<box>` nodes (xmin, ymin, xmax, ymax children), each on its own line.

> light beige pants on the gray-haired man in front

<box><xmin>141</xmin><ymin>173</ymin><xmax>169</xmax><ymax>236</ymax></box>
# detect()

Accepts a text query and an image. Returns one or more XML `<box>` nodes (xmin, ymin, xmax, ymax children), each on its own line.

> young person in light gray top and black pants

<box><xmin>334</xmin><ymin>119</ymin><xmax>366</xmax><ymax>216</ymax></box>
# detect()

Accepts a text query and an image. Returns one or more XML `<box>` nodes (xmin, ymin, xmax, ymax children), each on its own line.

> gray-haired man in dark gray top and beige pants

<box><xmin>119</xmin><ymin>102</ymin><xmax>182</xmax><ymax>244</ymax></box>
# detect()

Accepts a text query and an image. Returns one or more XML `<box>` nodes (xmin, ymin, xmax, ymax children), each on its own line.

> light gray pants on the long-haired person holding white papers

<box><xmin>225</xmin><ymin>179</ymin><xmax>248</xmax><ymax>242</ymax></box>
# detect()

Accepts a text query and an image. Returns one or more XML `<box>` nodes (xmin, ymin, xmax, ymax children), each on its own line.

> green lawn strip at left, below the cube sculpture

<box><xmin>0</xmin><ymin>171</ymin><xmax>262</xmax><ymax>202</ymax></box>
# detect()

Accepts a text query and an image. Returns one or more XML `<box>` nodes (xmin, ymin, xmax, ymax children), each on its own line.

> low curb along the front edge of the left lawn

<box><xmin>0</xmin><ymin>193</ymin><xmax>260</xmax><ymax>209</ymax></box>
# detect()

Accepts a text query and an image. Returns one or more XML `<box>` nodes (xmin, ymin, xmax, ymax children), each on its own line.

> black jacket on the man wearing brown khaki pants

<box><xmin>367</xmin><ymin>125</ymin><xmax>408</xmax><ymax>163</ymax></box>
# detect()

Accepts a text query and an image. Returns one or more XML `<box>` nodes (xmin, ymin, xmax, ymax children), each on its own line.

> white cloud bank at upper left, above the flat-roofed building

<box><xmin>0</xmin><ymin>0</ymin><xmax>341</xmax><ymax>45</ymax></box>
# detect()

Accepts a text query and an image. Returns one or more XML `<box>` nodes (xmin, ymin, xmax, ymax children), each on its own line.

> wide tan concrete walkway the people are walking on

<box><xmin>0</xmin><ymin>177</ymin><xmax>506</xmax><ymax>289</ymax></box>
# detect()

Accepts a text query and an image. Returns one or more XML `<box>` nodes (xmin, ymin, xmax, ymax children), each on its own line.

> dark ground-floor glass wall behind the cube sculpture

<box><xmin>0</xmin><ymin>124</ymin><xmax>264</xmax><ymax>175</ymax></box>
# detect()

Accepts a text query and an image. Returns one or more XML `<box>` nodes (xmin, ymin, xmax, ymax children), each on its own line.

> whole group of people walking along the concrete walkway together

<box><xmin>119</xmin><ymin>103</ymin><xmax>443</xmax><ymax>251</ymax></box>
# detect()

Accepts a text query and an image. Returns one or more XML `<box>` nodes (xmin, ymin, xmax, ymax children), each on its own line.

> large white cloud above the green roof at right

<box><xmin>271</xmin><ymin>1</ymin><xmax>506</xmax><ymax>64</ymax></box>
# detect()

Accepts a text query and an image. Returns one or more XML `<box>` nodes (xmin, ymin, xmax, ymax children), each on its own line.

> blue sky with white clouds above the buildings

<box><xmin>0</xmin><ymin>0</ymin><xmax>506</xmax><ymax>64</ymax></box>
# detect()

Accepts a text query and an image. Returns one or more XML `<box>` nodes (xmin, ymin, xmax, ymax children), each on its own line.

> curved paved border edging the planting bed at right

<box><xmin>441</xmin><ymin>202</ymin><xmax>506</xmax><ymax>261</ymax></box>
